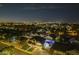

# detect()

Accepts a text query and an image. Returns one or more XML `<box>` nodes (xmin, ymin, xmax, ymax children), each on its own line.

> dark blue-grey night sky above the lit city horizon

<box><xmin>0</xmin><ymin>3</ymin><xmax>79</xmax><ymax>23</ymax></box>
